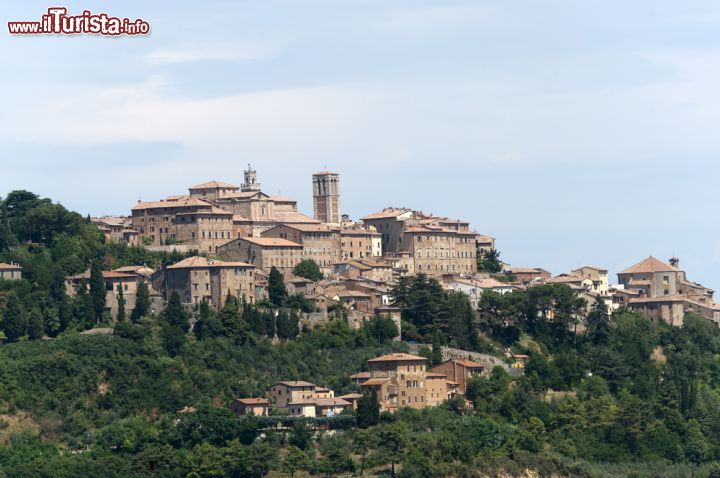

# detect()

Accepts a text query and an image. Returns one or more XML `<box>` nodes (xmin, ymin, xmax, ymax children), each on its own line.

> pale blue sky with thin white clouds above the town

<box><xmin>0</xmin><ymin>0</ymin><xmax>720</xmax><ymax>288</ymax></box>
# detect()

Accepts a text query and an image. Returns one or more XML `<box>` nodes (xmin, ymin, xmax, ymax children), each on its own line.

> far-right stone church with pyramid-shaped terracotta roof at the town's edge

<box><xmin>618</xmin><ymin>256</ymin><xmax>720</xmax><ymax>326</ymax></box>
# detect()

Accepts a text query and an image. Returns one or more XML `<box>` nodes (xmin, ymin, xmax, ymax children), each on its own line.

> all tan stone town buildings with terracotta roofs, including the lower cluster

<box><xmin>0</xmin><ymin>165</ymin><xmax>704</xmax><ymax>417</ymax></box>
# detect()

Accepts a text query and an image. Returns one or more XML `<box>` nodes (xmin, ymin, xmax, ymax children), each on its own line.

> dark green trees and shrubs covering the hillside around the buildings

<box><xmin>0</xmin><ymin>192</ymin><xmax>720</xmax><ymax>477</ymax></box>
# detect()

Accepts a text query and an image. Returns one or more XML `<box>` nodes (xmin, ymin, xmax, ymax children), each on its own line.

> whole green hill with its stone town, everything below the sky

<box><xmin>0</xmin><ymin>171</ymin><xmax>720</xmax><ymax>477</ymax></box>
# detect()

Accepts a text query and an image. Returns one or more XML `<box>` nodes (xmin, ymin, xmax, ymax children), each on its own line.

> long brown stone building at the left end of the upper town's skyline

<box><xmin>132</xmin><ymin>196</ymin><xmax>234</xmax><ymax>253</ymax></box>
